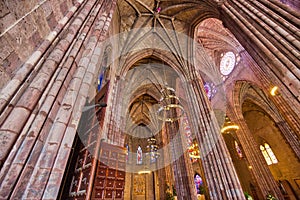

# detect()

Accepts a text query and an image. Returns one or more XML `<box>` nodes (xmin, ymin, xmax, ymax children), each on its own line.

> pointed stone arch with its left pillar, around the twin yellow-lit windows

<box><xmin>229</xmin><ymin>81</ymin><xmax>299</xmax><ymax>196</ymax></box>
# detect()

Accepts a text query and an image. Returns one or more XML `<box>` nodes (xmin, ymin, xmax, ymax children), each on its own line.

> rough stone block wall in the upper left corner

<box><xmin>0</xmin><ymin>0</ymin><xmax>74</xmax><ymax>90</ymax></box>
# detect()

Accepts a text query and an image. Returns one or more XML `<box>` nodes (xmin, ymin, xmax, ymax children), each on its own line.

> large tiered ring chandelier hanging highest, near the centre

<box><xmin>157</xmin><ymin>87</ymin><xmax>184</xmax><ymax>122</ymax></box>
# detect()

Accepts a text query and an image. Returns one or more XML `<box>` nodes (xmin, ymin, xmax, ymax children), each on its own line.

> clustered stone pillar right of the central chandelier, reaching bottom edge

<box><xmin>187</xmin><ymin>79</ymin><xmax>245</xmax><ymax>199</ymax></box>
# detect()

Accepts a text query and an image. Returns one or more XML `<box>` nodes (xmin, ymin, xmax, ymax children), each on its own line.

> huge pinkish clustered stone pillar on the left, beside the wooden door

<box><xmin>0</xmin><ymin>0</ymin><xmax>116</xmax><ymax>199</ymax></box>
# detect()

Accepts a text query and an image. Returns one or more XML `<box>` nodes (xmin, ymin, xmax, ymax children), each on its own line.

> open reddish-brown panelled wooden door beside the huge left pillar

<box><xmin>63</xmin><ymin>82</ymin><xmax>126</xmax><ymax>200</ymax></box>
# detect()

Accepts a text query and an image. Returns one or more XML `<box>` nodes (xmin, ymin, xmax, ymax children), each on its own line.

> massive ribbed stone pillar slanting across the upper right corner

<box><xmin>221</xmin><ymin>0</ymin><xmax>300</xmax><ymax>114</ymax></box>
